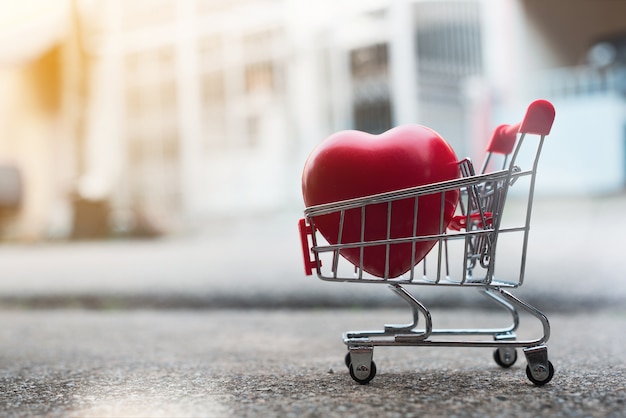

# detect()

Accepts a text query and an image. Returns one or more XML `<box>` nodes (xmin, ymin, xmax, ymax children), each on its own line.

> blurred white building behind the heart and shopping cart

<box><xmin>0</xmin><ymin>0</ymin><xmax>626</xmax><ymax>240</ymax></box>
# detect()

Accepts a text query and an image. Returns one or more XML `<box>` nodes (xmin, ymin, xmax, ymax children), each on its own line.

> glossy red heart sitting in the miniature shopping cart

<box><xmin>302</xmin><ymin>125</ymin><xmax>459</xmax><ymax>278</ymax></box>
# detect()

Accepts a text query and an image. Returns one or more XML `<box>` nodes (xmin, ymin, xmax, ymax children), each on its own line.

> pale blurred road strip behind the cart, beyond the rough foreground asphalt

<box><xmin>0</xmin><ymin>195</ymin><xmax>626</xmax><ymax>311</ymax></box>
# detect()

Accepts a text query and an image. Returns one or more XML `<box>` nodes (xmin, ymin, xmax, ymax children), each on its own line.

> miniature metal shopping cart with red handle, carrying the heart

<box><xmin>299</xmin><ymin>100</ymin><xmax>555</xmax><ymax>386</ymax></box>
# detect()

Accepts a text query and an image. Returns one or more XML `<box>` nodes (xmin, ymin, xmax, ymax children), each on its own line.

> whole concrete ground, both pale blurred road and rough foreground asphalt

<box><xmin>0</xmin><ymin>196</ymin><xmax>626</xmax><ymax>417</ymax></box>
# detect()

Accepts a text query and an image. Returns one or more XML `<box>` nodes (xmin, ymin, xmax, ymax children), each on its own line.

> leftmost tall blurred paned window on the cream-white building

<box><xmin>124</xmin><ymin>44</ymin><xmax>180</xmax><ymax>215</ymax></box>
